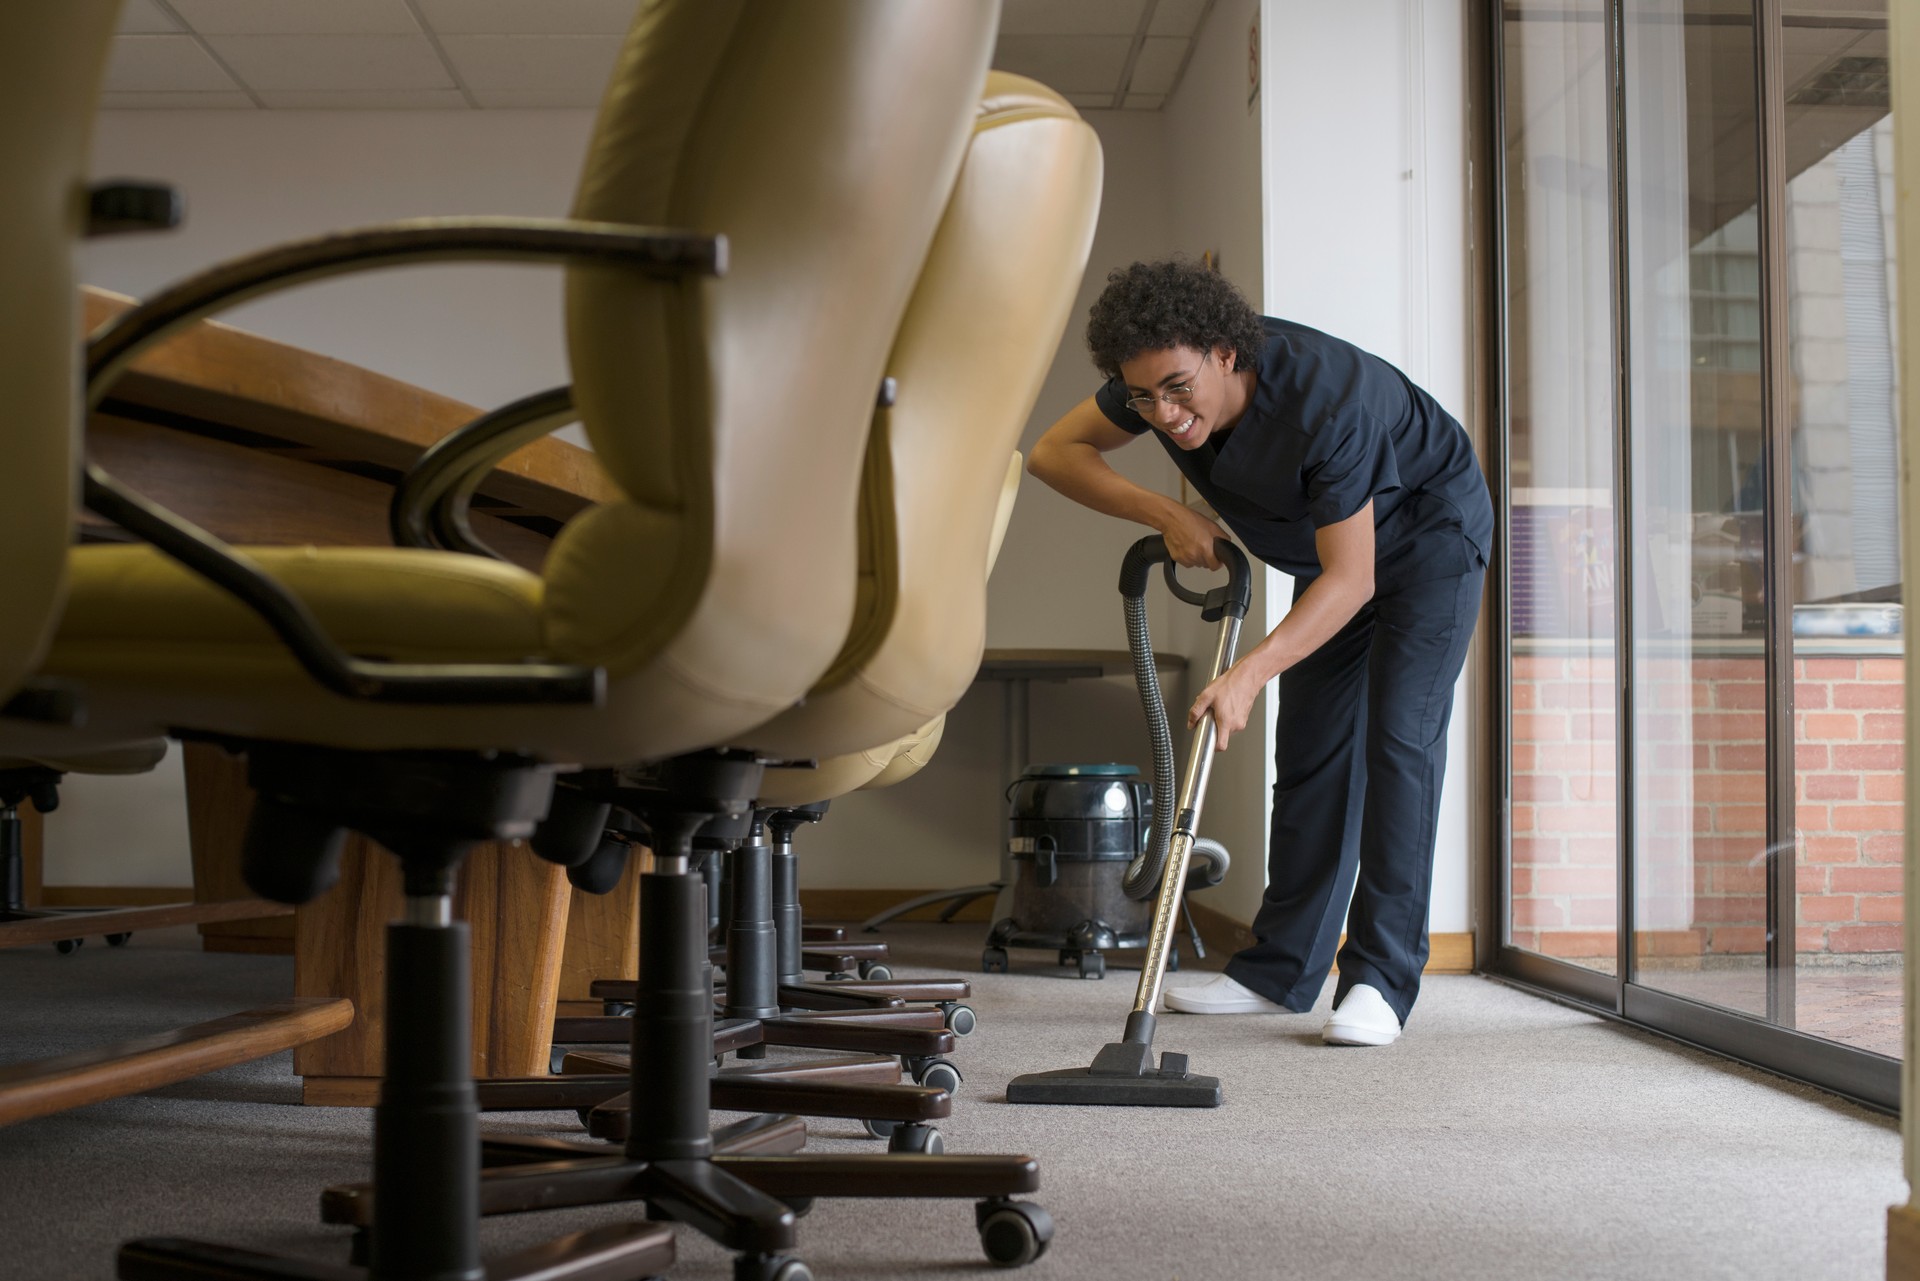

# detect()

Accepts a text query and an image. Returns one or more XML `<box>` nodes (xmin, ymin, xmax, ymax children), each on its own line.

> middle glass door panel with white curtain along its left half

<box><xmin>1622</xmin><ymin>0</ymin><xmax>1768</xmax><ymax>1014</ymax></box>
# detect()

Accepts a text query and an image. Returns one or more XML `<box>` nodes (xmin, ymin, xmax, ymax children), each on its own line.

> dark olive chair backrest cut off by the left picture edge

<box><xmin>0</xmin><ymin>0</ymin><xmax>119</xmax><ymax>703</ymax></box>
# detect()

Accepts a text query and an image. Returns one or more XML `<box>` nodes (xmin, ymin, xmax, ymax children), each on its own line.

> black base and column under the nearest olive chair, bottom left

<box><xmin>117</xmin><ymin>743</ymin><xmax>674</xmax><ymax>1281</ymax></box>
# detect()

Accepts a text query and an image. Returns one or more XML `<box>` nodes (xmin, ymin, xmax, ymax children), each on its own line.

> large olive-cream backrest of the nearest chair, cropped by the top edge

<box><xmin>547</xmin><ymin>0</ymin><xmax>998</xmax><ymax>741</ymax></box>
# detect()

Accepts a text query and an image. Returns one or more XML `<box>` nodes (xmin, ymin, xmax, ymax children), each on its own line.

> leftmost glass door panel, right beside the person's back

<box><xmin>1501</xmin><ymin>0</ymin><xmax>1619</xmax><ymax>974</ymax></box>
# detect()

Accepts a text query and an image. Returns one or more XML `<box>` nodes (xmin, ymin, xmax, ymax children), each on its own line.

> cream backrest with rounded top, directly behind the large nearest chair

<box><xmin>755</xmin><ymin>71</ymin><xmax>1100</xmax><ymax>757</ymax></box>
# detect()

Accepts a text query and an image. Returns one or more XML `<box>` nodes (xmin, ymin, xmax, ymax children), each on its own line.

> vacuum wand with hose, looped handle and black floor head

<box><xmin>1006</xmin><ymin>534</ymin><xmax>1252</xmax><ymax>1108</ymax></box>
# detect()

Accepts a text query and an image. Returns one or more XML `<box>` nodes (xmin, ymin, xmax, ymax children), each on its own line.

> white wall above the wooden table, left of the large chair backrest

<box><xmin>81</xmin><ymin>111</ymin><xmax>593</xmax><ymax>405</ymax></box>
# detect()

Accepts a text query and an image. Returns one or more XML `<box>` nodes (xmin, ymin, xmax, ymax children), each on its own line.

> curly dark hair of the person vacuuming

<box><xmin>1087</xmin><ymin>257</ymin><xmax>1267</xmax><ymax>378</ymax></box>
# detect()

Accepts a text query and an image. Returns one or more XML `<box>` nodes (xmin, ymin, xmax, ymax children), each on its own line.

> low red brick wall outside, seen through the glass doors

<box><xmin>1511</xmin><ymin>653</ymin><xmax>1905</xmax><ymax>958</ymax></box>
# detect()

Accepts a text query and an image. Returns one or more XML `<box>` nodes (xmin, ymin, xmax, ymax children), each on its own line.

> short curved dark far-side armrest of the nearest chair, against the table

<box><xmin>388</xmin><ymin>386</ymin><xmax>580</xmax><ymax>561</ymax></box>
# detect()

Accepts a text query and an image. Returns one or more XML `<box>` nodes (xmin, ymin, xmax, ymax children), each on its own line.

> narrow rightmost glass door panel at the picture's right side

<box><xmin>1784</xmin><ymin>4</ymin><xmax>1907</xmax><ymax>1056</ymax></box>
